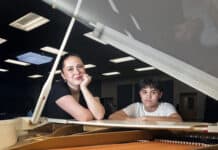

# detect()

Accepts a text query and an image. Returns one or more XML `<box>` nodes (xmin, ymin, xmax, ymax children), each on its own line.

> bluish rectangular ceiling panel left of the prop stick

<box><xmin>17</xmin><ymin>52</ymin><xmax>53</xmax><ymax>65</ymax></box>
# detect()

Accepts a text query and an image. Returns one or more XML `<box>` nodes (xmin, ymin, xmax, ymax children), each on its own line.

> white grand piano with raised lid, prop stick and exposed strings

<box><xmin>0</xmin><ymin>0</ymin><xmax>218</xmax><ymax>150</ymax></box>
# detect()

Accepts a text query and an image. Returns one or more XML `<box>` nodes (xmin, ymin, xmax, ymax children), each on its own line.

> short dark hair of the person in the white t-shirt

<box><xmin>138</xmin><ymin>79</ymin><xmax>163</xmax><ymax>92</ymax></box>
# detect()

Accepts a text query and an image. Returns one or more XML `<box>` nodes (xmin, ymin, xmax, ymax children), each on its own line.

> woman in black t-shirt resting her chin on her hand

<box><xmin>43</xmin><ymin>54</ymin><xmax>105</xmax><ymax>121</ymax></box>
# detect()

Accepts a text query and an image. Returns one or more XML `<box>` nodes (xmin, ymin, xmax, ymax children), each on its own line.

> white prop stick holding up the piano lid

<box><xmin>31</xmin><ymin>0</ymin><xmax>82</xmax><ymax>124</ymax></box>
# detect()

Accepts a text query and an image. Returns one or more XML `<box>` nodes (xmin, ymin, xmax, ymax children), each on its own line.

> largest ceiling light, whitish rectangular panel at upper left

<box><xmin>9</xmin><ymin>12</ymin><xmax>49</xmax><ymax>31</ymax></box>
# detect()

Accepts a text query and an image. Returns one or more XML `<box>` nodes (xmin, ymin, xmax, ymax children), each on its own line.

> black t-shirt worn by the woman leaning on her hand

<box><xmin>42</xmin><ymin>80</ymin><xmax>87</xmax><ymax>119</ymax></box>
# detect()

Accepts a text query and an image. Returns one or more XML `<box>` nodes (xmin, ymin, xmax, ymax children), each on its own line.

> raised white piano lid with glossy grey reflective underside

<box><xmin>43</xmin><ymin>0</ymin><xmax>218</xmax><ymax>100</ymax></box>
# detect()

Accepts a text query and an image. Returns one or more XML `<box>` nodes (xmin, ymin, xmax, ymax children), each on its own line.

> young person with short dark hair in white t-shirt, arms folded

<box><xmin>109</xmin><ymin>80</ymin><xmax>182</xmax><ymax>121</ymax></box>
